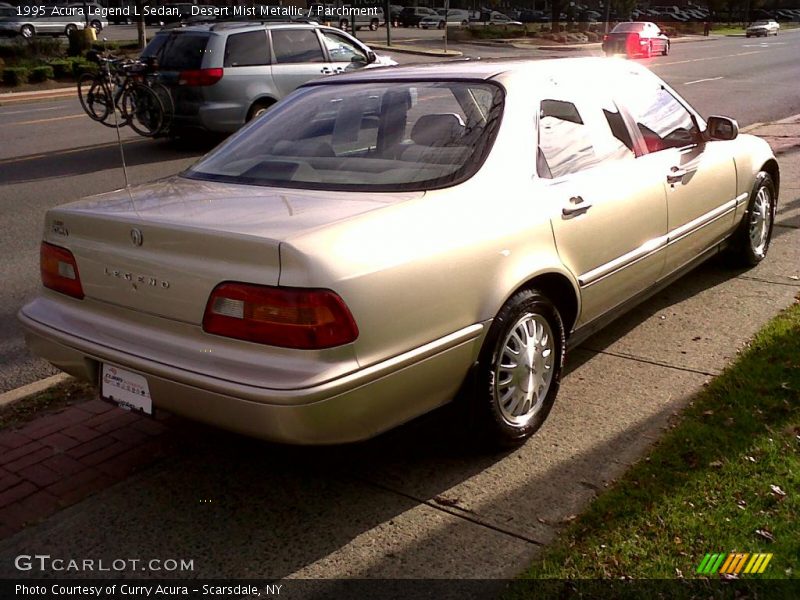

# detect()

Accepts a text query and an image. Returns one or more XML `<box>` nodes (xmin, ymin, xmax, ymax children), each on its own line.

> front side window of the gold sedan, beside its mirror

<box><xmin>620</xmin><ymin>73</ymin><xmax>700</xmax><ymax>152</ymax></box>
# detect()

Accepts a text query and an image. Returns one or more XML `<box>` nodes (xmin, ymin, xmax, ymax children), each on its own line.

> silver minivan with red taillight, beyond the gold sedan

<box><xmin>142</xmin><ymin>21</ymin><xmax>395</xmax><ymax>135</ymax></box>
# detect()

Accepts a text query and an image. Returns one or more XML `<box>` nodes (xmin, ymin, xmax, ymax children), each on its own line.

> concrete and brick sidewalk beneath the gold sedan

<box><xmin>0</xmin><ymin>116</ymin><xmax>800</xmax><ymax>578</ymax></box>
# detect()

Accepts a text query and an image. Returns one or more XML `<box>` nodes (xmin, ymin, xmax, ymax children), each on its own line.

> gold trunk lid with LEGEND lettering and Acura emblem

<box><xmin>45</xmin><ymin>177</ymin><xmax>421</xmax><ymax>324</ymax></box>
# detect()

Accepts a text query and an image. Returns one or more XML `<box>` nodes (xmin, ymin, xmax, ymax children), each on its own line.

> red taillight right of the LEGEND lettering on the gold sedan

<box><xmin>203</xmin><ymin>283</ymin><xmax>358</xmax><ymax>349</ymax></box>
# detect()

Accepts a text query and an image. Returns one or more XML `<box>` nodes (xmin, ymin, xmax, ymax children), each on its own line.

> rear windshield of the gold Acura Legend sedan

<box><xmin>184</xmin><ymin>81</ymin><xmax>503</xmax><ymax>191</ymax></box>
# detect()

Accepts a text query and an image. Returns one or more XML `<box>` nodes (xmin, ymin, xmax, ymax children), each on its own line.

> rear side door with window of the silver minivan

<box><xmin>270</xmin><ymin>27</ymin><xmax>333</xmax><ymax>97</ymax></box>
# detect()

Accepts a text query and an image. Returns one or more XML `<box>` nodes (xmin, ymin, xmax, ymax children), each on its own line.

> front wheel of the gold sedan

<box><xmin>730</xmin><ymin>171</ymin><xmax>778</xmax><ymax>267</ymax></box>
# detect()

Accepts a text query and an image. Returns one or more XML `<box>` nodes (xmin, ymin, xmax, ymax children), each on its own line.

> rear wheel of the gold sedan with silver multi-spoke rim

<box><xmin>474</xmin><ymin>289</ymin><xmax>565</xmax><ymax>447</ymax></box>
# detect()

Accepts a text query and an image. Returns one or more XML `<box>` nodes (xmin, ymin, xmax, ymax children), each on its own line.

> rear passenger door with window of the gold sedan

<box><xmin>537</xmin><ymin>85</ymin><xmax>667</xmax><ymax>325</ymax></box>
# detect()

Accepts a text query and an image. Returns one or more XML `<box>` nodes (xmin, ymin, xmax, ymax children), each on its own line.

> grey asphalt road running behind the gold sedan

<box><xmin>0</xmin><ymin>30</ymin><xmax>800</xmax><ymax>392</ymax></box>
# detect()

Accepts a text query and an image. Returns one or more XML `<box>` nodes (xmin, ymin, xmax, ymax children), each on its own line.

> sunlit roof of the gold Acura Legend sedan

<box><xmin>306</xmin><ymin>57</ymin><xmax>636</xmax><ymax>86</ymax></box>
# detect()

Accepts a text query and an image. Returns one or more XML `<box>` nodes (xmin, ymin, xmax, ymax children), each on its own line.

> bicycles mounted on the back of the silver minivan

<box><xmin>78</xmin><ymin>53</ymin><xmax>174</xmax><ymax>137</ymax></box>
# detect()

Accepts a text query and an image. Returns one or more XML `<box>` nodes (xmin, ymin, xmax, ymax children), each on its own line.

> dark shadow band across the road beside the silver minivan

<box><xmin>0</xmin><ymin>138</ymin><xmax>219</xmax><ymax>185</ymax></box>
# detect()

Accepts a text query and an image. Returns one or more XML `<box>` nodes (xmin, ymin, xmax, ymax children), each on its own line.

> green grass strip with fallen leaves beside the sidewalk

<box><xmin>506</xmin><ymin>296</ymin><xmax>800</xmax><ymax>598</ymax></box>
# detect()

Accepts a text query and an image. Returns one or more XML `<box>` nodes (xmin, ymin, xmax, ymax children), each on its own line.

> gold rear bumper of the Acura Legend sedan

<box><xmin>18</xmin><ymin>307</ymin><xmax>486</xmax><ymax>445</ymax></box>
